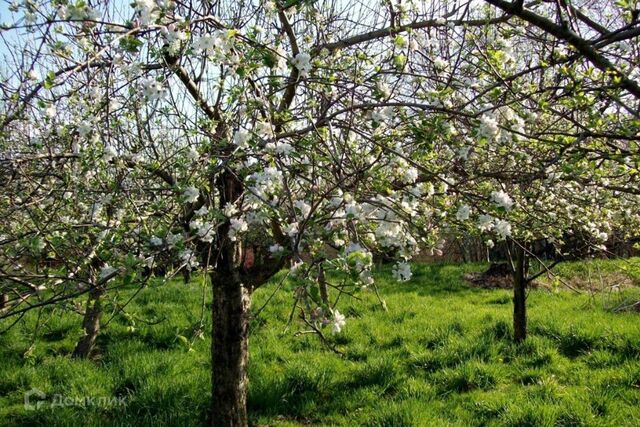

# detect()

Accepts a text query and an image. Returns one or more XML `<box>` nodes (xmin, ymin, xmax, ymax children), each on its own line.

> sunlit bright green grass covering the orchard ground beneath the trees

<box><xmin>0</xmin><ymin>259</ymin><xmax>640</xmax><ymax>426</ymax></box>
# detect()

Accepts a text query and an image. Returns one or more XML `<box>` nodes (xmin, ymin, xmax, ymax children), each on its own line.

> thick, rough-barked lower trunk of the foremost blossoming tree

<box><xmin>211</xmin><ymin>271</ymin><xmax>251</xmax><ymax>427</ymax></box>
